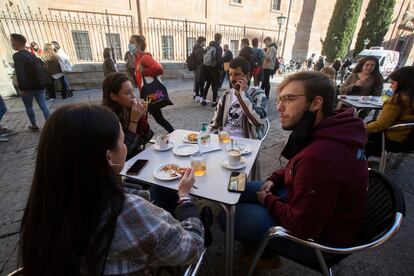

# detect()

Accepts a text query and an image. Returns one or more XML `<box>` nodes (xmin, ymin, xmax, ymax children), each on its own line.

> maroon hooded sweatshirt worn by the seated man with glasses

<box><xmin>265</xmin><ymin>110</ymin><xmax>368</xmax><ymax>246</ymax></box>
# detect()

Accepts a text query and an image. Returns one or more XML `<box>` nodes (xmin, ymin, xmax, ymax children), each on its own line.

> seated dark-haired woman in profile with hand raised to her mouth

<box><xmin>102</xmin><ymin>73</ymin><xmax>153</xmax><ymax>160</ymax></box>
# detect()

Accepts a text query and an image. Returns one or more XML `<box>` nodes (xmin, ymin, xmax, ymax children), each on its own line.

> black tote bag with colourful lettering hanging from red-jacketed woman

<box><xmin>140</xmin><ymin>77</ymin><xmax>173</xmax><ymax>112</ymax></box>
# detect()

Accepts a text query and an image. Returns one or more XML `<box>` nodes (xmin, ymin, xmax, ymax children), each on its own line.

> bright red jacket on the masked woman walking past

<box><xmin>135</xmin><ymin>53</ymin><xmax>164</xmax><ymax>90</ymax></box>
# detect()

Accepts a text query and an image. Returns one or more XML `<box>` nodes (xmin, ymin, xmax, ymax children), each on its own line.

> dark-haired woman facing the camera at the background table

<box><xmin>339</xmin><ymin>56</ymin><xmax>384</xmax><ymax>96</ymax></box>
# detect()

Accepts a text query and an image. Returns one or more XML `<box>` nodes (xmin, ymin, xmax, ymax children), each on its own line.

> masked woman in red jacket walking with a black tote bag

<box><xmin>128</xmin><ymin>35</ymin><xmax>174</xmax><ymax>133</ymax></box>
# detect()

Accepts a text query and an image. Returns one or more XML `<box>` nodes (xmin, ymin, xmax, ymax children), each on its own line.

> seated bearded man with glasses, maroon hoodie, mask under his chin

<box><xmin>226</xmin><ymin>71</ymin><xmax>368</xmax><ymax>261</ymax></box>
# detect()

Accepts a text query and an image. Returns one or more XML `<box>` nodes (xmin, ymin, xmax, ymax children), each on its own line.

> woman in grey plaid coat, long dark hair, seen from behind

<box><xmin>19</xmin><ymin>104</ymin><xmax>203</xmax><ymax>276</ymax></box>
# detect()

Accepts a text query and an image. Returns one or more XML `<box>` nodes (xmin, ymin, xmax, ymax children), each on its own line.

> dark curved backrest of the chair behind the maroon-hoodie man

<box><xmin>360</xmin><ymin>170</ymin><xmax>405</xmax><ymax>244</ymax></box>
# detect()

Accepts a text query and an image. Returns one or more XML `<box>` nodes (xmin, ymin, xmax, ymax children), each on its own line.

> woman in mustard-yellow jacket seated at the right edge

<box><xmin>366</xmin><ymin>66</ymin><xmax>414</xmax><ymax>156</ymax></box>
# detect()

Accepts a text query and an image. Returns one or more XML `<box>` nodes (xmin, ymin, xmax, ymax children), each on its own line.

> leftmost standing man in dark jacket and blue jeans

<box><xmin>10</xmin><ymin>34</ymin><xmax>50</xmax><ymax>131</ymax></box>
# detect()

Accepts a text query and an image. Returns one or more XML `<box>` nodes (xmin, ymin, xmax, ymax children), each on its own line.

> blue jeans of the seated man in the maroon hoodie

<box><xmin>219</xmin><ymin>181</ymin><xmax>317</xmax><ymax>262</ymax></box>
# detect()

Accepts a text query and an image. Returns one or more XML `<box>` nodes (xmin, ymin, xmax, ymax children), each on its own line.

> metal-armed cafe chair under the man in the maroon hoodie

<box><xmin>247</xmin><ymin>170</ymin><xmax>405</xmax><ymax>275</ymax></box>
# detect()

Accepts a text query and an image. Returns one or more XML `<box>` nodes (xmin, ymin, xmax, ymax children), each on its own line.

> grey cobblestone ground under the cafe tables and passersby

<box><xmin>0</xmin><ymin>79</ymin><xmax>414</xmax><ymax>275</ymax></box>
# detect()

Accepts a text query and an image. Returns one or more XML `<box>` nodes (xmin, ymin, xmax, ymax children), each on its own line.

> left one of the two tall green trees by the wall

<box><xmin>322</xmin><ymin>0</ymin><xmax>363</xmax><ymax>61</ymax></box>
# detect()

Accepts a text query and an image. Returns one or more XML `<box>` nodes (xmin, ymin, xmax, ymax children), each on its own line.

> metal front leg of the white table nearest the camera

<box><xmin>220</xmin><ymin>203</ymin><xmax>236</xmax><ymax>276</ymax></box>
